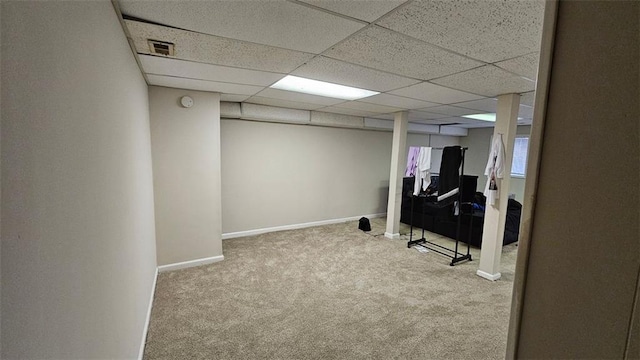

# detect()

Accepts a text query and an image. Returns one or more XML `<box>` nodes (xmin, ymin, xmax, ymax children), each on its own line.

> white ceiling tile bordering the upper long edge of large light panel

<box><xmin>291</xmin><ymin>56</ymin><xmax>420</xmax><ymax>92</ymax></box>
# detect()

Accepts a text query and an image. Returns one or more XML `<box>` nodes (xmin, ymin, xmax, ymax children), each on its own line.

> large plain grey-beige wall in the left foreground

<box><xmin>1</xmin><ymin>1</ymin><xmax>156</xmax><ymax>359</ymax></box>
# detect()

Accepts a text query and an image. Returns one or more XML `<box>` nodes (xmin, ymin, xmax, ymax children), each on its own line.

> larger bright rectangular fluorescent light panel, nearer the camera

<box><xmin>270</xmin><ymin>75</ymin><xmax>379</xmax><ymax>100</ymax></box>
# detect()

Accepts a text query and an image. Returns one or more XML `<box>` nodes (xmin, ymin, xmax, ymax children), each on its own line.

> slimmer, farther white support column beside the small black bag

<box><xmin>384</xmin><ymin>111</ymin><xmax>409</xmax><ymax>239</ymax></box>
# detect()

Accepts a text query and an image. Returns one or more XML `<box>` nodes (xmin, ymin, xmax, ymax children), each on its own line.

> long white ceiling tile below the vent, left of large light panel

<box><xmin>140</xmin><ymin>55</ymin><xmax>284</xmax><ymax>86</ymax></box>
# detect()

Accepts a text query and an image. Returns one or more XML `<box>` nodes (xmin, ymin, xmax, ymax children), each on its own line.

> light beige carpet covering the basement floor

<box><xmin>144</xmin><ymin>219</ymin><xmax>517</xmax><ymax>359</ymax></box>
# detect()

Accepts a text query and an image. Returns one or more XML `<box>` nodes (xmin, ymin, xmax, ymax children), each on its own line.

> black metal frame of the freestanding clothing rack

<box><xmin>407</xmin><ymin>147</ymin><xmax>473</xmax><ymax>266</ymax></box>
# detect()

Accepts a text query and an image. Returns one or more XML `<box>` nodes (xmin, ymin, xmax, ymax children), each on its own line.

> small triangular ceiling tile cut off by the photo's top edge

<box><xmin>301</xmin><ymin>0</ymin><xmax>406</xmax><ymax>22</ymax></box>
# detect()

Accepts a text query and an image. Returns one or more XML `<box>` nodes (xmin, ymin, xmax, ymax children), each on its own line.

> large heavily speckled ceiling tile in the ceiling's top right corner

<box><xmin>377</xmin><ymin>0</ymin><xmax>545</xmax><ymax>63</ymax></box>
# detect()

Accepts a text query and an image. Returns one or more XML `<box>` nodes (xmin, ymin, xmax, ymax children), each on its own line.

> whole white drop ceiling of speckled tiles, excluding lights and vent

<box><xmin>117</xmin><ymin>0</ymin><xmax>544</xmax><ymax>128</ymax></box>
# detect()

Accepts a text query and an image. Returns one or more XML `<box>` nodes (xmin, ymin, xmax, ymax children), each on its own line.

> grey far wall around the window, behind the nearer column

<box><xmin>460</xmin><ymin>125</ymin><xmax>531</xmax><ymax>203</ymax></box>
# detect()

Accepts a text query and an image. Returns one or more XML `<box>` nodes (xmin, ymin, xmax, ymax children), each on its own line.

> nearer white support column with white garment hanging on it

<box><xmin>476</xmin><ymin>94</ymin><xmax>520</xmax><ymax>281</ymax></box>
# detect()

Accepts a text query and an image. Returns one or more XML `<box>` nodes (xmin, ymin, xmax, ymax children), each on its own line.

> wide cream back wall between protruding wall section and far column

<box><xmin>221</xmin><ymin>119</ymin><xmax>398</xmax><ymax>234</ymax></box>
